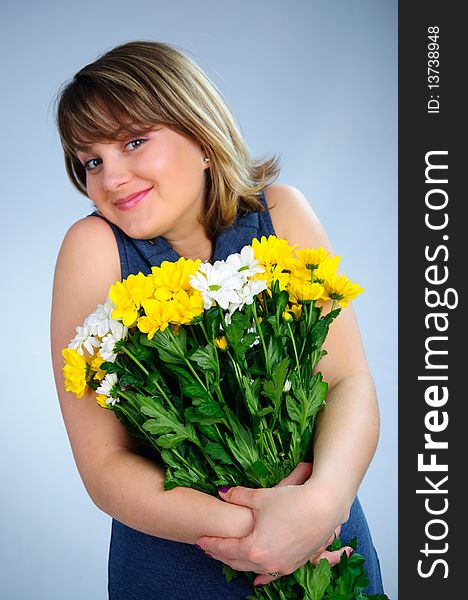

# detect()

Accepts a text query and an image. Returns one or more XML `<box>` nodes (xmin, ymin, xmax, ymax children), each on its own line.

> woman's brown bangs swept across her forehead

<box><xmin>57</xmin><ymin>77</ymin><xmax>166</xmax><ymax>156</ymax></box>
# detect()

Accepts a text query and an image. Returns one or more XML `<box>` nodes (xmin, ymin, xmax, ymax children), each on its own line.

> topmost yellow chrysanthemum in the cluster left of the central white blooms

<box><xmin>151</xmin><ymin>257</ymin><xmax>201</xmax><ymax>300</ymax></box>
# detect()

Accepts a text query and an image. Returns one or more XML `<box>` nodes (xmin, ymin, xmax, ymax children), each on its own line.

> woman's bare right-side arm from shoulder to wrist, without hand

<box><xmin>268</xmin><ymin>185</ymin><xmax>379</xmax><ymax>521</ymax></box>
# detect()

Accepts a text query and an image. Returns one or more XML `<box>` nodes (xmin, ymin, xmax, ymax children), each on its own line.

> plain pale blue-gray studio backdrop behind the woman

<box><xmin>0</xmin><ymin>0</ymin><xmax>397</xmax><ymax>600</ymax></box>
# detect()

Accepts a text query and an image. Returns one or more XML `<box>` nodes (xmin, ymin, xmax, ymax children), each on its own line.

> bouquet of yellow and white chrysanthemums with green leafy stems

<box><xmin>62</xmin><ymin>236</ymin><xmax>386</xmax><ymax>600</ymax></box>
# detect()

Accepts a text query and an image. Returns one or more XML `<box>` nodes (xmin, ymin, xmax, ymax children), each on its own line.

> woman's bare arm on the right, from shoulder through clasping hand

<box><xmin>197</xmin><ymin>185</ymin><xmax>379</xmax><ymax>584</ymax></box>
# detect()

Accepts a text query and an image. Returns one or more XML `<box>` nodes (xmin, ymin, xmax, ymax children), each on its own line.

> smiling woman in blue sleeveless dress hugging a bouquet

<box><xmin>52</xmin><ymin>42</ymin><xmax>381</xmax><ymax>600</ymax></box>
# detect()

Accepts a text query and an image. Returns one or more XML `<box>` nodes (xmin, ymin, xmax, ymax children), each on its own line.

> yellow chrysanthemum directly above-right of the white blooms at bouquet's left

<box><xmin>109</xmin><ymin>273</ymin><xmax>154</xmax><ymax>327</ymax></box>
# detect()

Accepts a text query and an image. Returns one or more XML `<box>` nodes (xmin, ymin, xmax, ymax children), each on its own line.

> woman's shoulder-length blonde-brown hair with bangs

<box><xmin>56</xmin><ymin>41</ymin><xmax>279</xmax><ymax>236</ymax></box>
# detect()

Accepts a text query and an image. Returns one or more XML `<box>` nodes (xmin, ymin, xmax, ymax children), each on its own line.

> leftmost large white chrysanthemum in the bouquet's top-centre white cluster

<box><xmin>190</xmin><ymin>260</ymin><xmax>243</xmax><ymax>310</ymax></box>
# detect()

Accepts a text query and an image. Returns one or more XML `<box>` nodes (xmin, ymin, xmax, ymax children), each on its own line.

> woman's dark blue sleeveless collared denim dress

<box><xmin>93</xmin><ymin>193</ymin><xmax>383</xmax><ymax>600</ymax></box>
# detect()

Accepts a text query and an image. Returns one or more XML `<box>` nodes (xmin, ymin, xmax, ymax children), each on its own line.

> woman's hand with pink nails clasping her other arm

<box><xmin>196</xmin><ymin>463</ymin><xmax>352</xmax><ymax>585</ymax></box>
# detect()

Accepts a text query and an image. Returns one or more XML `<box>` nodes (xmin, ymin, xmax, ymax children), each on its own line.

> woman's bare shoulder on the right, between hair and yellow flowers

<box><xmin>265</xmin><ymin>184</ymin><xmax>331</xmax><ymax>251</ymax></box>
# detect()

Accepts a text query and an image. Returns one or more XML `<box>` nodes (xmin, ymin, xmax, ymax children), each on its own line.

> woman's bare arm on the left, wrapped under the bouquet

<box><xmin>51</xmin><ymin>217</ymin><xmax>252</xmax><ymax>543</ymax></box>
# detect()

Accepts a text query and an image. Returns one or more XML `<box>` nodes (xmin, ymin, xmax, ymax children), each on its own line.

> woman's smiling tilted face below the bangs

<box><xmin>77</xmin><ymin>127</ymin><xmax>209</xmax><ymax>240</ymax></box>
